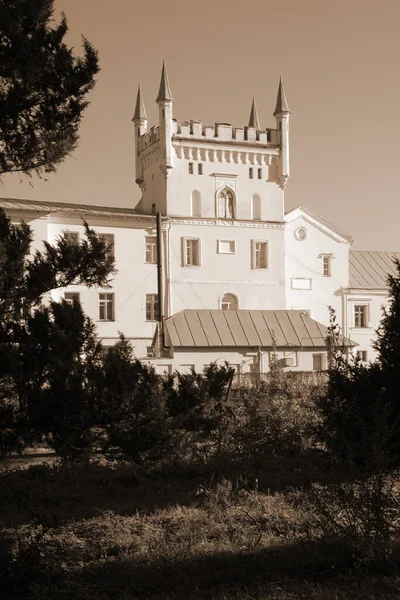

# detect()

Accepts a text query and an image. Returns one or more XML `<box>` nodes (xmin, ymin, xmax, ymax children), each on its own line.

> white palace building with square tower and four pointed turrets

<box><xmin>0</xmin><ymin>67</ymin><xmax>400</xmax><ymax>373</ymax></box>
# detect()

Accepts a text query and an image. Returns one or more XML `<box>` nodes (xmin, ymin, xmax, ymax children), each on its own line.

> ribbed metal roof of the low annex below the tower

<box><xmin>165</xmin><ymin>309</ymin><xmax>357</xmax><ymax>348</ymax></box>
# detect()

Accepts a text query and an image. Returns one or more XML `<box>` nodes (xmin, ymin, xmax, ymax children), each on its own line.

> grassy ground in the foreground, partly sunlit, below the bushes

<box><xmin>0</xmin><ymin>462</ymin><xmax>400</xmax><ymax>600</ymax></box>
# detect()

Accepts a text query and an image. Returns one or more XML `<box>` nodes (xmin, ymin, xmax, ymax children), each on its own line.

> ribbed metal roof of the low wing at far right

<box><xmin>349</xmin><ymin>250</ymin><xmax>400</xmax><ymax>289</ymax></box>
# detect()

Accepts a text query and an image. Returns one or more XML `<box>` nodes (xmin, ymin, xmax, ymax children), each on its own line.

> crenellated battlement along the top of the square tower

<box><xmin>172</xmin><ymin>120</ymin><xmax>278</xmax><ymax>146</ymax></box>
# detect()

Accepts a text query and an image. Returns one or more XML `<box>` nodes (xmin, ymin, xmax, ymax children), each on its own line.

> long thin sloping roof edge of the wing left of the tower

<box><xmin>0</xmin><ymin>198</ymin><xmax>154</xmax><ymax>217</ymax></box>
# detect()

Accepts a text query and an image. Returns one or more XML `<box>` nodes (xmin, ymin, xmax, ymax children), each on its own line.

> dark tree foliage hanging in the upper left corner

<box><xmin>0</xmin><ymin>0</ymin><xmax>99</xmax><ymax>176</ymax></box>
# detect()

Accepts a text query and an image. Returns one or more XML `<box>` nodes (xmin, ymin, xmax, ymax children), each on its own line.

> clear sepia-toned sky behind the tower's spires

<box><xmin>0</xmin><ymin>0</ymin><xmax>400</xmax><ymax>251</ymax></box>
